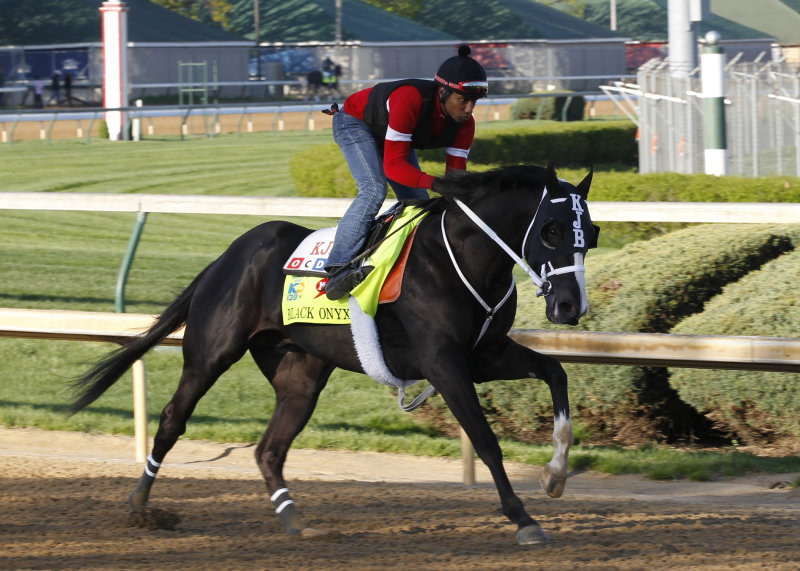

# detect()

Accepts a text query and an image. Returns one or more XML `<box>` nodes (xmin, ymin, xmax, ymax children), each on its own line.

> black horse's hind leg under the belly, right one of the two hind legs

<box><xmin>251</xmin><ymin>346</ymin><xmax>334</xmax><ymax>534</ymax></box>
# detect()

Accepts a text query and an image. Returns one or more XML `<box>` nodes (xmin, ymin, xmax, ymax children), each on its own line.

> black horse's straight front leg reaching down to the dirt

<box><xmin>427</xmin><ymin>353</ymin><xmax>548</xmax><ymax>545</ymax></box>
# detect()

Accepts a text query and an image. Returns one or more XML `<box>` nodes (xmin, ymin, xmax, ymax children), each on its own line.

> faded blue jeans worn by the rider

<box><xmin>326</xmin><ymin>111</ymin><xmax>428</xmax><ymax>267</ymax></box>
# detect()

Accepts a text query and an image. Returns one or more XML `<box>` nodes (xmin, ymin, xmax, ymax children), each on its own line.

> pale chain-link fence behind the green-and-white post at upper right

<box><xmin>604</xmin><ymin>60</ymin><xmax>800</xmax><ymax>177</ymax></box>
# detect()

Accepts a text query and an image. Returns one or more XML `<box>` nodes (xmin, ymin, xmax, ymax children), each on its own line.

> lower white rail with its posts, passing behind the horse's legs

<box><xmin>0</xmin><ymin>308</ymin><xmax>800</xmax><ymax>470</ymax></box>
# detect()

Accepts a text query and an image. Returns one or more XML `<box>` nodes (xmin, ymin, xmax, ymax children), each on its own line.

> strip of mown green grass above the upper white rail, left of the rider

<box><xmin>0</xmin><ymin>130</ymin><xmax>332</xmax><ymax>196</ymax></box>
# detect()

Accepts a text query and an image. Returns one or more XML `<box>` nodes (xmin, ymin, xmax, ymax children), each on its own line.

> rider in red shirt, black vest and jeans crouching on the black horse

<box><xmin>325</xmin><ymin>45</ymin><xmax>489</xmax><ymax>299</ymax></box>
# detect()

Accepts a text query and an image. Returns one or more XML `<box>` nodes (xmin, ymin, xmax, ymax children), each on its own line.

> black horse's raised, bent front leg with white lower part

<box><xmin>471</xmin><ymin>337</ymin><xmax>573</xmax><ymax>498</ymax></box>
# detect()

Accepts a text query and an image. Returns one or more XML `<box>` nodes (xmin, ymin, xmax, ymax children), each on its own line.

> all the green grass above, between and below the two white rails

<box><xmin>0</xmin><ymin>132</ymin><xmax>800</xmax><ymax>479</ymax></box>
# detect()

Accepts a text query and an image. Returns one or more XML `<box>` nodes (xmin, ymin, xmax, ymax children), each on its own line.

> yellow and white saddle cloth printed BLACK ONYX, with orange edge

<box><xmin>281</xmin><ymin>206</ymin><xmax>425</xmax><ymax>325</ymax></box>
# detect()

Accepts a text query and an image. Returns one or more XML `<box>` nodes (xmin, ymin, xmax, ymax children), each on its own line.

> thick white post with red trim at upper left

<box><xmin>100</xmin><ymin>0</ymin><xmax>128</xmax><ymax>141</ymax></box>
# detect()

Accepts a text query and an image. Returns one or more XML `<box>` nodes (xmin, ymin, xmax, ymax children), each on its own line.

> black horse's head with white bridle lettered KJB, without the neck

<box><xmin>522</xmin><ymin>165</ymin><xmax>599</xmax><ymax>325</ymax></box>
